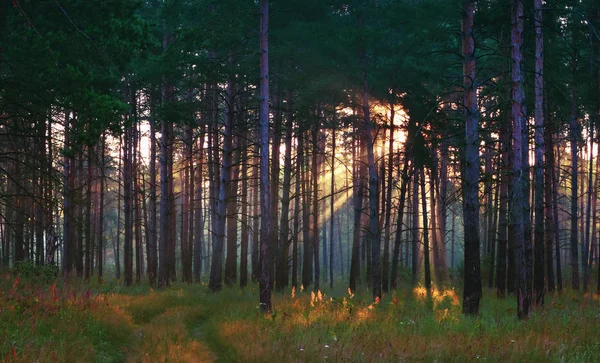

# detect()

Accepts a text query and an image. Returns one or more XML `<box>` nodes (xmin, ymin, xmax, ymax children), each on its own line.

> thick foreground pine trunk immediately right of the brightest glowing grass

<box><xmin>462</xmin><ymin>0</ymin><xmax>481</xmax><ymax>315</ymax></box>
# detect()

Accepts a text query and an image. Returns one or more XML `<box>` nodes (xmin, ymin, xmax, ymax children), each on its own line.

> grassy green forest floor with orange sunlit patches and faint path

<box><xmin>0</xmin><ymin>273</ymin><xmax>600</xmax><ymax>362</ymax></box>
